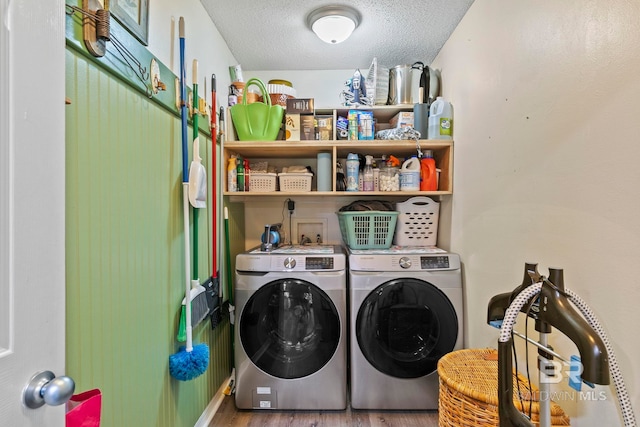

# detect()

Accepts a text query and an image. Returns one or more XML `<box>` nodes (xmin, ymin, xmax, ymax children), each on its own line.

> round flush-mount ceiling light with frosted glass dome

<box><xmin>307</xmin><ymin>6</ymin><xmax>360</xmax><ymax>44</ymax></box>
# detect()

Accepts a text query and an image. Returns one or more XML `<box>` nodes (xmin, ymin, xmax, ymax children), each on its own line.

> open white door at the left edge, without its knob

<box><xmin>0</xmin><ymin>0</ymin><xmax>65</xmax><ymax>427</ymax></box>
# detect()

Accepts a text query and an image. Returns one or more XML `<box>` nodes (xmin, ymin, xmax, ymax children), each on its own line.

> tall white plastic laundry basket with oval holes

<box><xmin>393</xmin><ymin>196</ymin><xmax>440</xmax><ymax>246</ymax></box>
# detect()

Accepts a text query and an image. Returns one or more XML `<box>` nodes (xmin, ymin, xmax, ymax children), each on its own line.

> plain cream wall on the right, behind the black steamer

<box><xmin>433</xmin><ymin>0</ymin><xmax>640</xmax><ymax>427</ymax></box>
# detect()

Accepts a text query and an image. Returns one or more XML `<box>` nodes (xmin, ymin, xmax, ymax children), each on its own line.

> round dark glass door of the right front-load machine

<box><xmin>356</xmin><ymin>278</ymin><xmax>458</xmax><ymax>378</ymax></box>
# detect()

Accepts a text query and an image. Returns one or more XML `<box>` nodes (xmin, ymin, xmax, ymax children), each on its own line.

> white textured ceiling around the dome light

<box><xmin>201</xmin><ymin>0</ymin><xmax>473</xmax><ymax>71</ymax></box>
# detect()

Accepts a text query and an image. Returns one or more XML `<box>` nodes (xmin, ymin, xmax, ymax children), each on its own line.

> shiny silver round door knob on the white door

<box><xmin>22</xmin><ymin>371</ymin><xmax>76</xmax><ymax>409</ymax></box>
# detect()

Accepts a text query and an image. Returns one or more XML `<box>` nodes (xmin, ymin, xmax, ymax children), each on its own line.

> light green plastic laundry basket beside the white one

<box><xmin>338</xmin><ymin>211</ymin><xmax>398</xmax><ymax>249</ymax></box>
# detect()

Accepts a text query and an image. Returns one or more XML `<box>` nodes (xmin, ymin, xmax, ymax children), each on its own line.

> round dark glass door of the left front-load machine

<box><xmin>239</xmin><ymin>279</ymin><xmax>340</xmax><ymax>379</ymax></box>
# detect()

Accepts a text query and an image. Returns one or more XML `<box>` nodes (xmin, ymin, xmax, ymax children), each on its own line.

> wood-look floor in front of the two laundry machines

<box><xmin>209</xmin><ymin>396</ymin><xmax>438</xmax><ymax>427</ymax></box>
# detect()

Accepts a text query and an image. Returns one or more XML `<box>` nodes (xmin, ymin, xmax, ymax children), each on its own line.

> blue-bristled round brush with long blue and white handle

<box><xmin>169</xmin><ymin>17</ymin><xmax>209</xmax><ymax>381</ymax></box>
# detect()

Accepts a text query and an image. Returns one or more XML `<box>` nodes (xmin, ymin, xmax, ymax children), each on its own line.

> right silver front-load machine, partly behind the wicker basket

<box><xmin>348</xmin><ymin>247</ymin><xmax>464</xmax><ymax>410</ymax></box>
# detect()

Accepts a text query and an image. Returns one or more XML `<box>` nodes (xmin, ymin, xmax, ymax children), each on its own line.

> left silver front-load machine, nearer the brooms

<box><xmin>235</xmin><ymin>246</ymin><xmax>348</xmax><ymax>410</ymax></box>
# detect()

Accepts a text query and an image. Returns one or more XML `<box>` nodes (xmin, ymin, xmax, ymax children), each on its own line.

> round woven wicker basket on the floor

<box><xmin>438</xmin><ymin>348</ymin><xmax>570</xmax><ymax>427</ymax></box>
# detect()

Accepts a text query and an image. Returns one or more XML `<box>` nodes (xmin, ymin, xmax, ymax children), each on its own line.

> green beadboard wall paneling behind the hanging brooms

<box><xmin>66</xmin><ymin>48</ymin><xmax>231</xmax><ymax>427</ymax></box>
